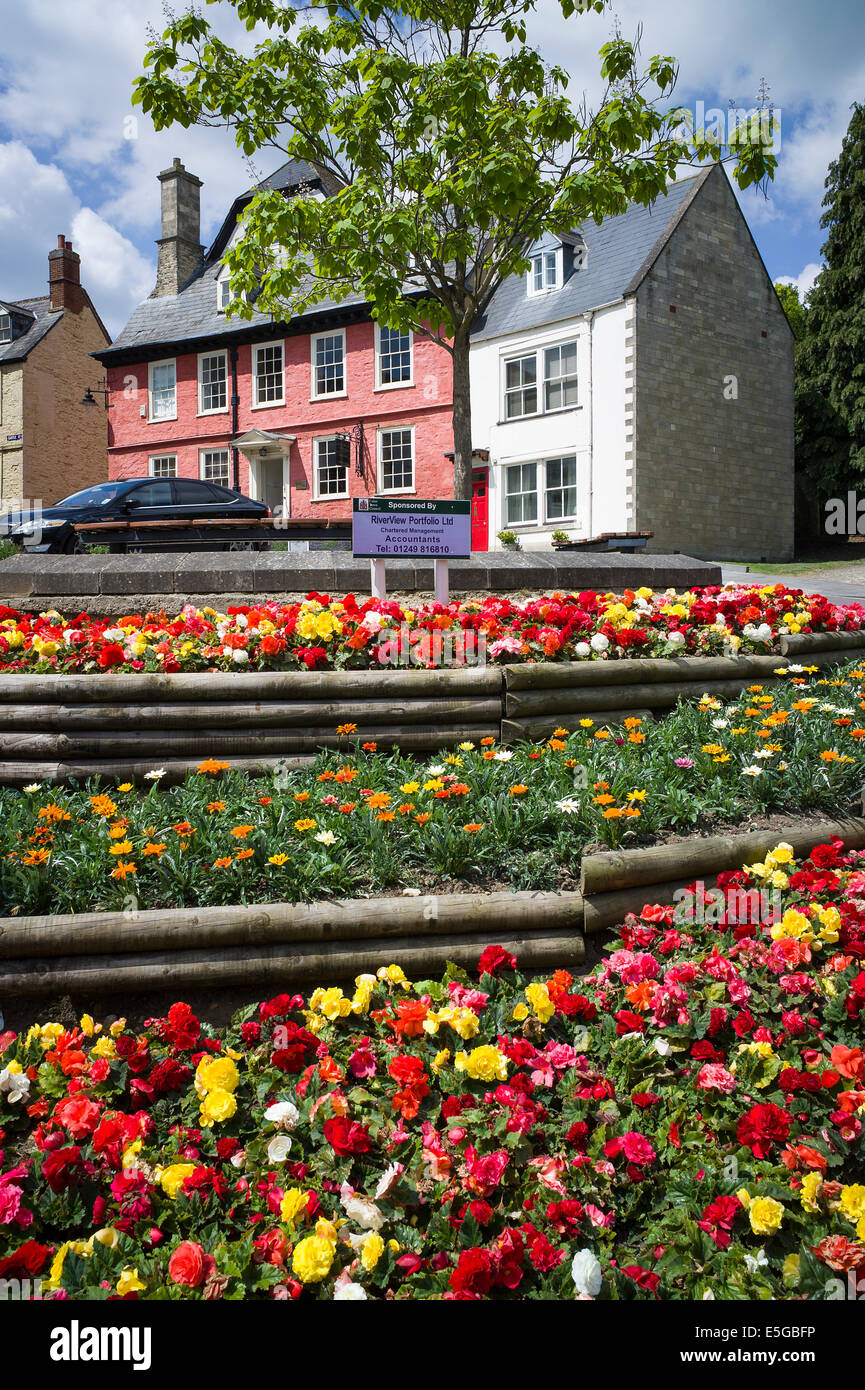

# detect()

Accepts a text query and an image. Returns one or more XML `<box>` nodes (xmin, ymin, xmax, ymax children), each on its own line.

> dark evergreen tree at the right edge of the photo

<box><xmin>795</xmin><ymin>103</ymin><xmax>865</xmax><ymax>496</ymax></box>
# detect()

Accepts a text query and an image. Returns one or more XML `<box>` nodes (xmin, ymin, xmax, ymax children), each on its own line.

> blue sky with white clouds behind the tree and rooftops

<box><xmin>0</xmin><ymin>0</ymin><xmax>865</xmax><ymax>332</ymax></box>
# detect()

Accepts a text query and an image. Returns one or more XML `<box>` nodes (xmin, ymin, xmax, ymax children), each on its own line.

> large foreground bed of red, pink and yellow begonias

<box><xmin>0</xmin><ymin>841</ymin><xmax>865</xmax><ymax>1301</ymax></box>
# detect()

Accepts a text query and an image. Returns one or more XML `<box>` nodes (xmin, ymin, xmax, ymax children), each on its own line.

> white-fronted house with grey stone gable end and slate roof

<box><xmin>471</xmin><ymin>165</ymin><xmax>793</xmax><ymax>560</ymax></box>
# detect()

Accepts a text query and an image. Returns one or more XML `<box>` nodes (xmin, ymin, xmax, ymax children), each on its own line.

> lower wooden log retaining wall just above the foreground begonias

<box><xmin>0</xmin><ymin>817</ymin><xmax>865</xmax><ymax>999</ymax></box>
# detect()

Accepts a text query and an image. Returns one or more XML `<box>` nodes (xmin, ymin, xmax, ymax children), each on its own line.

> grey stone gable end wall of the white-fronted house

<box><xmin>631</xmin><ymin>167</ymin><xmax>793</xmax><ymax>560</ymax></box>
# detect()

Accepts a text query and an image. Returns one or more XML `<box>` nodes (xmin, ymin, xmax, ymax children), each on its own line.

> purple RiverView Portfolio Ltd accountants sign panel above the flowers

<box><xmin>352</xmin><ymin>498</ymin><xmax>471</xmax><ymax>560</ymax></box>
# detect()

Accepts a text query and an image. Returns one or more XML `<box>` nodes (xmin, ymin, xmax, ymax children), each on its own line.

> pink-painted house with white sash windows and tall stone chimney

<box><xmin>95</xmin><ymin>160</ymin><xmax>453</xmax><ymax>520</ymax></box>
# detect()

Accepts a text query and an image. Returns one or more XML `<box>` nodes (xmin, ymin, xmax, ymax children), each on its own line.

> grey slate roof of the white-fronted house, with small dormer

<box><xmin>471</xmin><ymin>168</ymin><xmax>712</xmax><ymax>342</ymax></box>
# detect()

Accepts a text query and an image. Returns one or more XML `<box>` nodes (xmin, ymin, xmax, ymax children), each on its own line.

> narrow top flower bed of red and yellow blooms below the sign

<box><xmin>0</xmin><ymin>584</ymin><xmax>865</xmax><ymax>673</ymax></box>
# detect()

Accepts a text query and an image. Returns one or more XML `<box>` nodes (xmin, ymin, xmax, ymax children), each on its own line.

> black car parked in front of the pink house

<box><xmin>10</xmin><ymin>478</ymin><xmax>270</xmax><ymax>555</ymax></box>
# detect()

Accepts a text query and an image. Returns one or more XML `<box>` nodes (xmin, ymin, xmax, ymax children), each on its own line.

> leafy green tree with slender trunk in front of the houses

<box><xmin>134</xmin><ymin>0</ymin><xmax>776</xmax><ymax>498</ymax></box>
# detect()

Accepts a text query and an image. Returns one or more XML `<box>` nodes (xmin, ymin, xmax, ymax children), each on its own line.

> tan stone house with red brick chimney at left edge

<box><xmin>0</xmin><ymin>236</ymin><xmax>111</xmax><ymax>513</ymax></box>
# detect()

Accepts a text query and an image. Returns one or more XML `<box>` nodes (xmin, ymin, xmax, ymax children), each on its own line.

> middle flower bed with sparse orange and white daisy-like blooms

<box><xmin>0</xmin><ymin>664</ymin><xmax>865</xmax><ymax>913</ymax></box>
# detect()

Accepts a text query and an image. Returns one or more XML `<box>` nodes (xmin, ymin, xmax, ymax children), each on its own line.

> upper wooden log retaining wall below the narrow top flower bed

<box><xmin>0</xmin><ymin>632</ymin><xmax>865</xmax><ymax>785</ymax></box>
